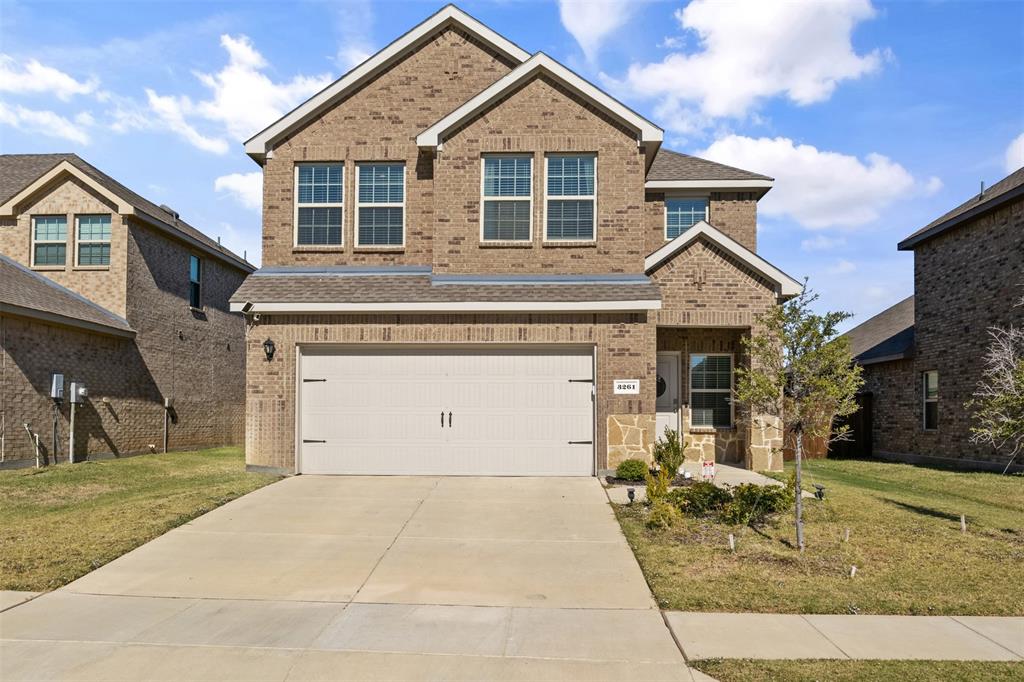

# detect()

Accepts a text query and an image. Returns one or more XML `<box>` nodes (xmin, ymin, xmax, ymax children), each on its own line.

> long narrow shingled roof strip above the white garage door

<box><xmin>231</xmin><ymin>272</ymin><xmax>662</xmax><ymax>303</ymax></box>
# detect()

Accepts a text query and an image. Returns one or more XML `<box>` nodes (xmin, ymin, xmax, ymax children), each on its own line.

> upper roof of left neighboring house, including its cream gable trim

<box><xmin>0</xmin><ymin>154</ymin><xmax>256</xmax><ymax>272</ymax></box>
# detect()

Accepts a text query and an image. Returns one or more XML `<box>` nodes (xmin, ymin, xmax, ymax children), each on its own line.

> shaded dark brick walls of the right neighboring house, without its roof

<box><xmin>864</xmin><ymin>193</ymin><xmax>1024</xmax><ymax>466</ymax></box>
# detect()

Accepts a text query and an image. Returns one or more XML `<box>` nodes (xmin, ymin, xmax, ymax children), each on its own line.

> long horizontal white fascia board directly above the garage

<box><xmin>231</xmin><ymin>299</ymin><xmax>662</xmax><ymax>313</ymax></box>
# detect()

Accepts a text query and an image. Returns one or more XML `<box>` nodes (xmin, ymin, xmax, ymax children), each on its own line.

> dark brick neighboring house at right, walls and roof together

<box><xmin>847</xmin><ymin>168</ymin><xmax>1024</xmax><ymax>471</ymax></box>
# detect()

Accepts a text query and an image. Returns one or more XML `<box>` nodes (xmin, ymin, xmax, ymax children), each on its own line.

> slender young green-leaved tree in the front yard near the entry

<box><xmin>735</xmin><ymin>282</ymin><xmax>863</xmax><ymax>552</ymax></box>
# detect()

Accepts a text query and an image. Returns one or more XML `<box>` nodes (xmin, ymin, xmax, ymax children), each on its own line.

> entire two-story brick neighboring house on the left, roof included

<box><xmin>0</xmin><ymin>154</ymin><xmax>255</xmax><ymax>462</ymax></box>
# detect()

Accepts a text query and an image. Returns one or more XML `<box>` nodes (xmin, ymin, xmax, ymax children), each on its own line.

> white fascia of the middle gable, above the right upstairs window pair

<box><xmin>416</xmin><ymin>52</ymin><xmax>665</xmax><ymax>148</ymax></box>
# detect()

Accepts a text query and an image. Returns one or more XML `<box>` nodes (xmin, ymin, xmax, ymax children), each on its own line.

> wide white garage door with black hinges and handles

<box><xmin>299</xmin><ymin>346</ymin><xmax>594</xmax><ymax>476</ymax></box>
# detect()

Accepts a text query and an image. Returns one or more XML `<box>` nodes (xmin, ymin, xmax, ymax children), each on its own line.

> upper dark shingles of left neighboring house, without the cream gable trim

<box><xmin>0</xmin><ymin>154</ymin><xmax>255</xmax><ymax>270</ymax></box>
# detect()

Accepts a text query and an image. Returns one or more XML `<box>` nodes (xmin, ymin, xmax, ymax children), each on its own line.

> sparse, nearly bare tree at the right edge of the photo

<box><xmin>967</xmin><ymin>292</ymin><xmax>1024</xmax><ymax>473</ymax></box>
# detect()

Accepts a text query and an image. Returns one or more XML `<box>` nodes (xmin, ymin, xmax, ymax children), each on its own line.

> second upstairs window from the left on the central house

<box><xmin>355</xmin><ymin>164</ymin><xmax>406</xmax><ymax>246</ymax></box>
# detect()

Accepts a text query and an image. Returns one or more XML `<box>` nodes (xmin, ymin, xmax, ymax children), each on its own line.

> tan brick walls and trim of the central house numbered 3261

<box><xmin>232</xmin><ymin>6</ymin><xmax>799</xmax><ymax>472</ymax></box>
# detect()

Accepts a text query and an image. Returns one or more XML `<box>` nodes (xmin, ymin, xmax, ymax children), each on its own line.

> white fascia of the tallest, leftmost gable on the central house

<box><xmin>245</xmin><ymin>5</ymin><xmax>529</xmax><ymax>159</ymax></box>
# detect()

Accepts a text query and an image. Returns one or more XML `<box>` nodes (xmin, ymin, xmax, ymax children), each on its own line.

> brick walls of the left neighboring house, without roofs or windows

<box><xmin>0</xmin><ymin>178</ymin><xmax>246</xmax><ymax>461</ymax></box>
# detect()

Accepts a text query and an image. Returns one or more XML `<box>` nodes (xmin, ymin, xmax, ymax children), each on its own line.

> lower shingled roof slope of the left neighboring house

<box><xmin>0</xmin><ymin>255</ymin><xmax>135</xmax><ymax>336</ymax></box>
